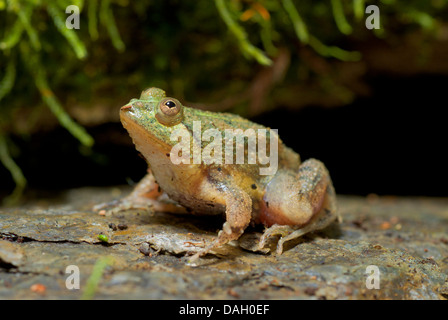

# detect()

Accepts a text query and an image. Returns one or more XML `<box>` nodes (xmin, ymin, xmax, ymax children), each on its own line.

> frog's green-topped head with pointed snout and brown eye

<box><xmin>120</xmin><ymin>88</ymin><xmax>184</xmax><ymax>155</ymax></box>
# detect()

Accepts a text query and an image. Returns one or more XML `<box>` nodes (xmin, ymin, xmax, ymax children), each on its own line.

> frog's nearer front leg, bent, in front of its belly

<box><xmin>189</xmin><ymin>187</ymin><xmax>252</xmax><ymax>263</ymax></box>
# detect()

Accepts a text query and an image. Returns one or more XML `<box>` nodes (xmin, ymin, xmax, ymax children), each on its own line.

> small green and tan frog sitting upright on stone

<box><xmin>95</xmin><ymin>87</ymin><xmax>340</xmax><ymax>262</ymax></box>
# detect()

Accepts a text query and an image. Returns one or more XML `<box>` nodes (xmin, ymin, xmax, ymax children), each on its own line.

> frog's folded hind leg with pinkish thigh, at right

<box><xmin>259</xmin><ymin>159</ymin><xmax>338</xmax><ymax>254</ymax></box>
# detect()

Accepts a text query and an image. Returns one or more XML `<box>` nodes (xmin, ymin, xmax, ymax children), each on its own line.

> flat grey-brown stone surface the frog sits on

<box><xmin>0</xmin><ymin>188</ymin><xmax>448</xmax><ymax>299</ymax></box>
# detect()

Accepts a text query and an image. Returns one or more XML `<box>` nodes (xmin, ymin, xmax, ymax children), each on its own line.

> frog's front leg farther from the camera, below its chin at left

<box><xmin>93</xmin><ymin>169</ymin><xmax>186</xmax><ymax>213</ymax></box>
